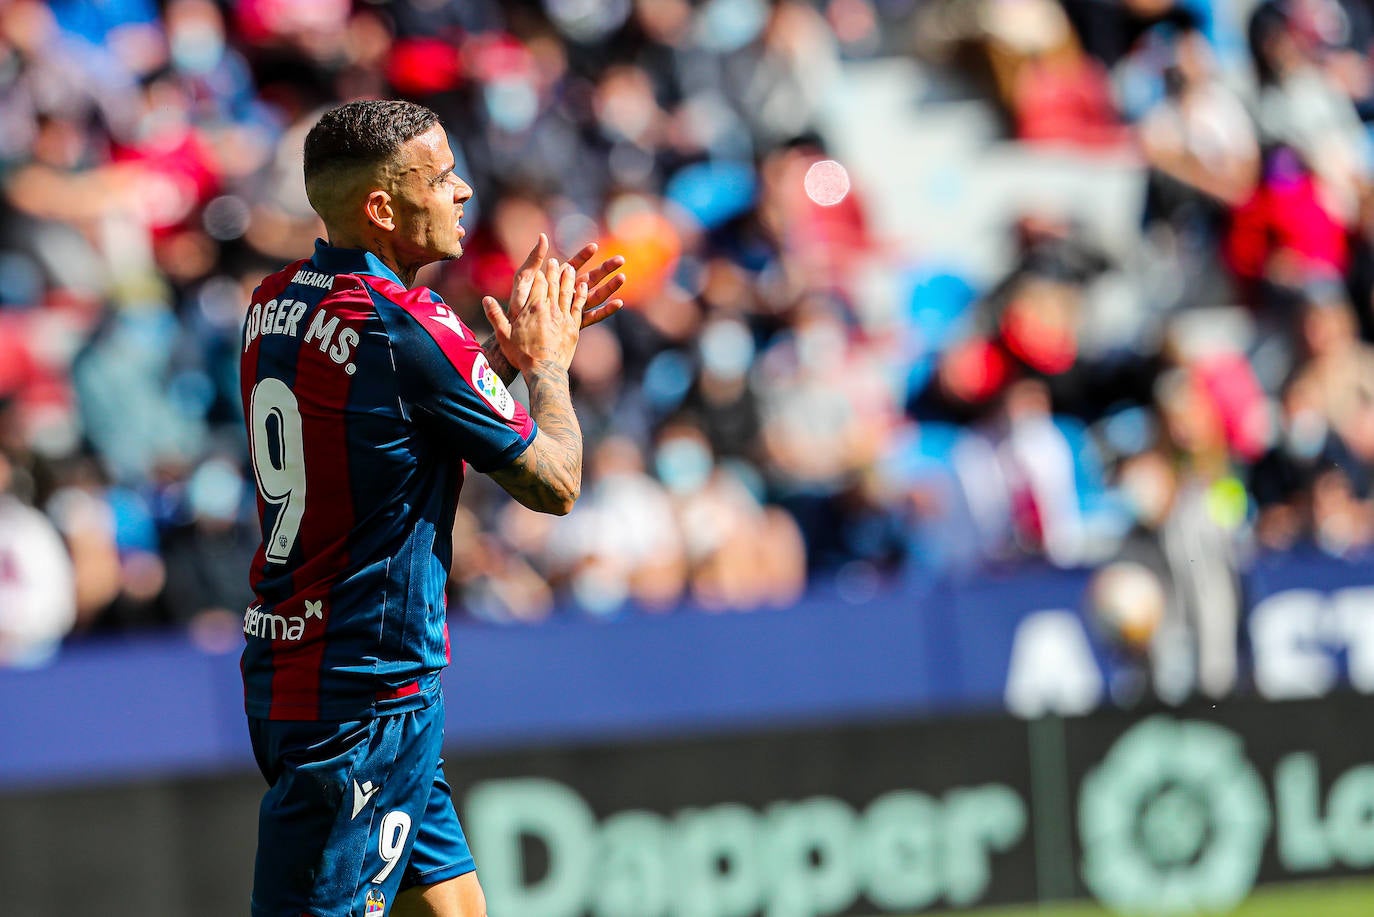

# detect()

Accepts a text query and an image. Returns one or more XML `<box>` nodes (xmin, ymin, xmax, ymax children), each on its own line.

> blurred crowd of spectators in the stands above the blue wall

<box><xmin>0</xmin><ymin>0</ymin><xmax>1374</xmax><ymax>694</ymax></box>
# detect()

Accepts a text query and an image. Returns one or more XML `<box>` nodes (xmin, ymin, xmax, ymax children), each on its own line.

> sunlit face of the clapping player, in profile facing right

<box><xmin>393</xmin><ymin>124</ymin><xmax>473</xmax><ymax>264</ymax></box>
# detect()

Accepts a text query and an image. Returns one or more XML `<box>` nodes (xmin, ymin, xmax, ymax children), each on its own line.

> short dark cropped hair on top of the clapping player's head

<box><xmin>305</xmin><ymin>99</ymin><xmax>438</xmax><ymax>184</ymax></box>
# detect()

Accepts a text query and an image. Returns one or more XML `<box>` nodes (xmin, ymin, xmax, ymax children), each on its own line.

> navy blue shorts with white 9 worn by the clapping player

<box><xmin>249</xmin><ymin>700</ymin><xmax>475</xmax><ymax>917</ymax></box>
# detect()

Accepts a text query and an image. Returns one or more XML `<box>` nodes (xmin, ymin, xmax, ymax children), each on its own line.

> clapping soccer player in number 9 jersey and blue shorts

<box><xmin>242</xmin><ymin>102</ymin><xmax>624</xmax><ymax>917</ymax></box>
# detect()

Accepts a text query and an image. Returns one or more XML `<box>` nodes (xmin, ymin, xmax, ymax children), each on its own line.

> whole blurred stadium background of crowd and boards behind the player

<box><xmin>8</xmin><ymin>0</ymin><xmax>1374</xmax><ymax>917</ymax></box>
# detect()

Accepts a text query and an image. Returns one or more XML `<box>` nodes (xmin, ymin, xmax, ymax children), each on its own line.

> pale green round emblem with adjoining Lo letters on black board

<box><xmin>1079</xmin><ymin>715</ymin><xmax>1374</xmax><ymax>916</ymax></box>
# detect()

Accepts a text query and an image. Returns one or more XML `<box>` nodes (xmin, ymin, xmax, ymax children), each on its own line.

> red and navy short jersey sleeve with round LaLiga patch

<box><xmin>372</xmin><ymin>287</ymin><xmax>537</xmax><ymax>472</ymax></box>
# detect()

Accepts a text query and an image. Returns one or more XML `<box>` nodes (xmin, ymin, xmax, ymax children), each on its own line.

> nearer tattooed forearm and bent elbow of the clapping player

<box><xmin>492</xmin><ymin>360</ymin><xmax>583</xmax><ymax>516</ymax></box>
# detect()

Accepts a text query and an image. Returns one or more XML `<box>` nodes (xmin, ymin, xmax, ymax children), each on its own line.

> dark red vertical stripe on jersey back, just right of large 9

<box><xmin>259</xmin><ymin>287</ymin><xmax>372</xmax><ymax>719</ymax></box>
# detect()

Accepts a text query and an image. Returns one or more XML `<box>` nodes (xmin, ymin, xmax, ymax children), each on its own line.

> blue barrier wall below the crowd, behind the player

<box><xmin>8</xmin><ymin>555</ymin><xmax>1374</xmax><ymax>786</ymax></box>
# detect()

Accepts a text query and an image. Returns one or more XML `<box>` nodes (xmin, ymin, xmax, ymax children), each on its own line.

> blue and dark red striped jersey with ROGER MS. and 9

<box><xmin>240</xmin><ymin>242</ymin><xmax>536</xmax><ymax>720</ymax></box>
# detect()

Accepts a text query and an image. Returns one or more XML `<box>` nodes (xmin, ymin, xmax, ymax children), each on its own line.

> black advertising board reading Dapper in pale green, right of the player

<box><xmin>451</xmin><ymin>694</ymin><xmax>1374</xmax><ymax>917</ymax></box>
